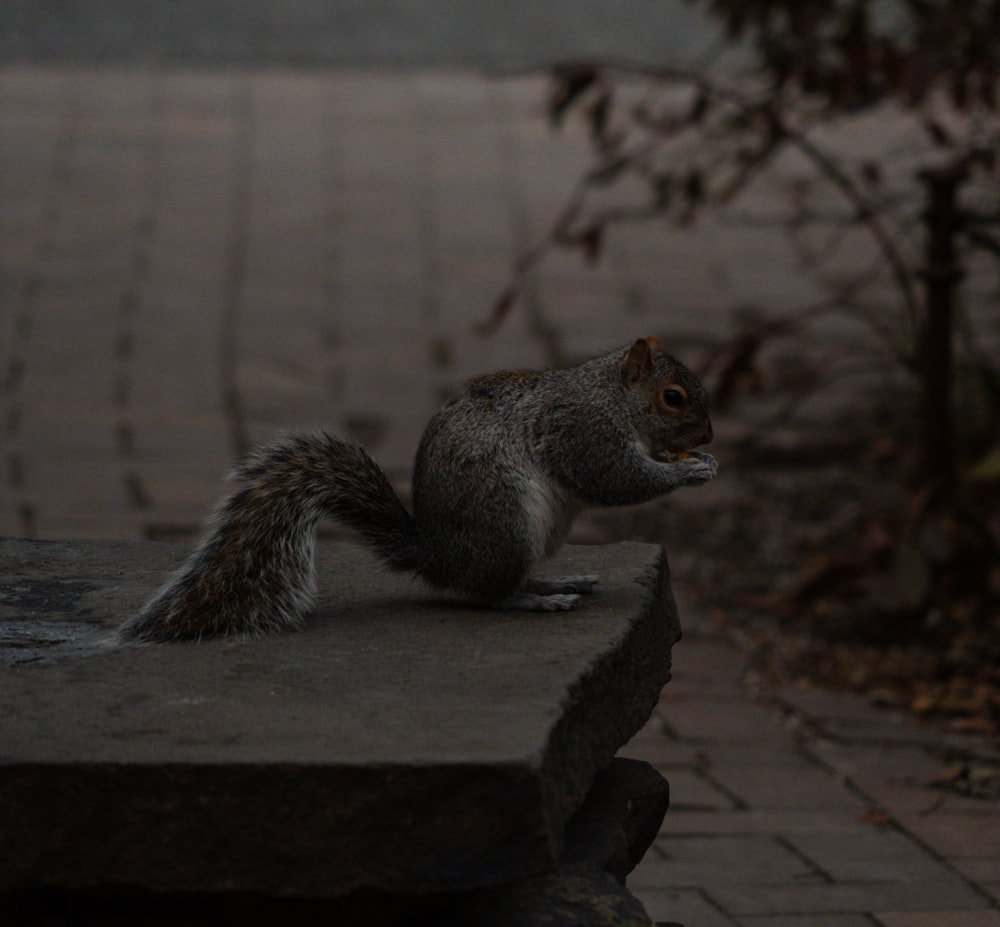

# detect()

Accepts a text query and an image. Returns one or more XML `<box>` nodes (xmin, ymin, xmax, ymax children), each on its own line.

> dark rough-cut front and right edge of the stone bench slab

<box><xmin>0</xmin><ymin>542</ymin><xmax>679</xmax><ymax>897</ymax></box>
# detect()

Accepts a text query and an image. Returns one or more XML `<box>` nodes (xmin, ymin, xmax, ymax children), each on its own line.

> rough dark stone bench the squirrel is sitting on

<box><xmin>0</xmin><ymin>540</ymin><xmax>680</xmax><ymax>925</ymax></box>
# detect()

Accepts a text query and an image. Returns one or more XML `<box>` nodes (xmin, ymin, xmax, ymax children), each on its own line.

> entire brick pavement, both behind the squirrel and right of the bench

<box><xmin>0</xmin><ymin>65</ymin><xmax>1000</xmax><ymax>927</ymax></box>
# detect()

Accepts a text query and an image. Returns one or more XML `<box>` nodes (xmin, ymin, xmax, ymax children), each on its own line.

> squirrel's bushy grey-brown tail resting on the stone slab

<box><xmin>121</xmin><ymin>433</ymin><xmax>419</xmax><ymax>641</ymax></box>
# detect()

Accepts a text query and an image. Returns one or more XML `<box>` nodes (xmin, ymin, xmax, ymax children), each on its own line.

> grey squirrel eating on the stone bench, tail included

<box><xmin>121</xmin><ymin>337</ymin><xmax>717</xmax><ymax>641</ymax></box>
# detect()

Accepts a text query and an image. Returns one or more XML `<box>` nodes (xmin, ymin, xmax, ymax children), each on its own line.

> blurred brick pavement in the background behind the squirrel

<box><xmin>0</xmin><ymin>65</ymin><xmax>852</xmax><ymax>538</ymax></box>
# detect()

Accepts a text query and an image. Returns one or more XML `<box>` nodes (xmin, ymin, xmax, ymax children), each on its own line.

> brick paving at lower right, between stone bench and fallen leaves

<box><xmin>625</xmin><ymin>640</ymin><xmax>1000</xmax><ymax>927</ymax></box>
